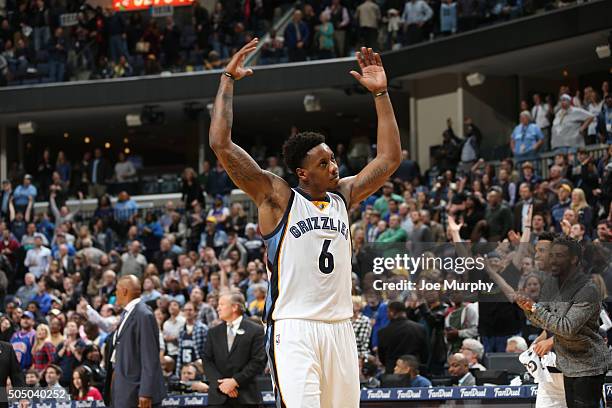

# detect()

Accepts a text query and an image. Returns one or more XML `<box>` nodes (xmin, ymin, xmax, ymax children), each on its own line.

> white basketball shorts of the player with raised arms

<box><xmin>266</xmin><ymin>319</ymin><xmax>360</xmax><ymax>408</ymax></box>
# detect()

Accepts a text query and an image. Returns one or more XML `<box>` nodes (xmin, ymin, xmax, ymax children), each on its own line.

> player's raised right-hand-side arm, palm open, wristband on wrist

<box><xmin>339</xmin><ymin>47</ymin><xmax>402</xmax><ymax>206</ymax></box>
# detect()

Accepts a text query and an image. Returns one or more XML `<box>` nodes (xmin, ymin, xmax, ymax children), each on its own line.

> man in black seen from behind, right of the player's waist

<box><xmin>378</xmin><ymin>302</ymin><xmax>428</xmax><ymax>374</ymax></box>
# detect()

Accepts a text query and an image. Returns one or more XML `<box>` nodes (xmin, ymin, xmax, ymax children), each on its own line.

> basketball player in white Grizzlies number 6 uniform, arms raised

<box><xmin>210</xmin><ymin>39</ymin><xmax>401</xmax><ymax>408</ymax></box>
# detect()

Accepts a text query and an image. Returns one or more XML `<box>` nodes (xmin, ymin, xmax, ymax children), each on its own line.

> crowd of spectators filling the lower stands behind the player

<box><xmin>0</xmin><ymin>79</ymin><xmax>612</xmax><ymax>399</ymax></box>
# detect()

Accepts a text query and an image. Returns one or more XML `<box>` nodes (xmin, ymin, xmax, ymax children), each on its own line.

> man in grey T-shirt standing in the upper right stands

<box><xmin>550</xmin><ymin>94</ymin><xmax>594</xmax><ymax>151</ymax></box>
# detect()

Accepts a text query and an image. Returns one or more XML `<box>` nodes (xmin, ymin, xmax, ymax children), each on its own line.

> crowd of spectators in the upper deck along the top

<box><xmin>0</xmin><ymin>0</ymin><xmax>592</xmax><ymax>86</ymax></box>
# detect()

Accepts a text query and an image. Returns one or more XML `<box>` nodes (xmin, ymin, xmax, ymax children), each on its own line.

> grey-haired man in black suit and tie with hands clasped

<box><xmin>204</xmin><ymin>293</ymin><xmax>267</xmax><ymax>407</ymax></box>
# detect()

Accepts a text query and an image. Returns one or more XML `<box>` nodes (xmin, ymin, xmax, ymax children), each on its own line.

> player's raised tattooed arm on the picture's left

<box><xmin>210</xmin><ymin>38</ymin><xmax>289</xmax><ymax>207</ymax></box>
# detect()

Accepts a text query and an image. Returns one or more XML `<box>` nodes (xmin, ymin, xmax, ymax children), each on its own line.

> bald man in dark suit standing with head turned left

<box><xmin>111</xmin><ymin>275</ymin><xmax>166</xmax><ymax>408</ymax></box>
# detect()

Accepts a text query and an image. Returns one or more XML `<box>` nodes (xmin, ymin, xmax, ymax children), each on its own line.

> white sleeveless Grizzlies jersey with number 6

<box><xmin>264</xmin><ymin>189</ymin><xmax>353</xmax><ymax>321</ymax></box>
